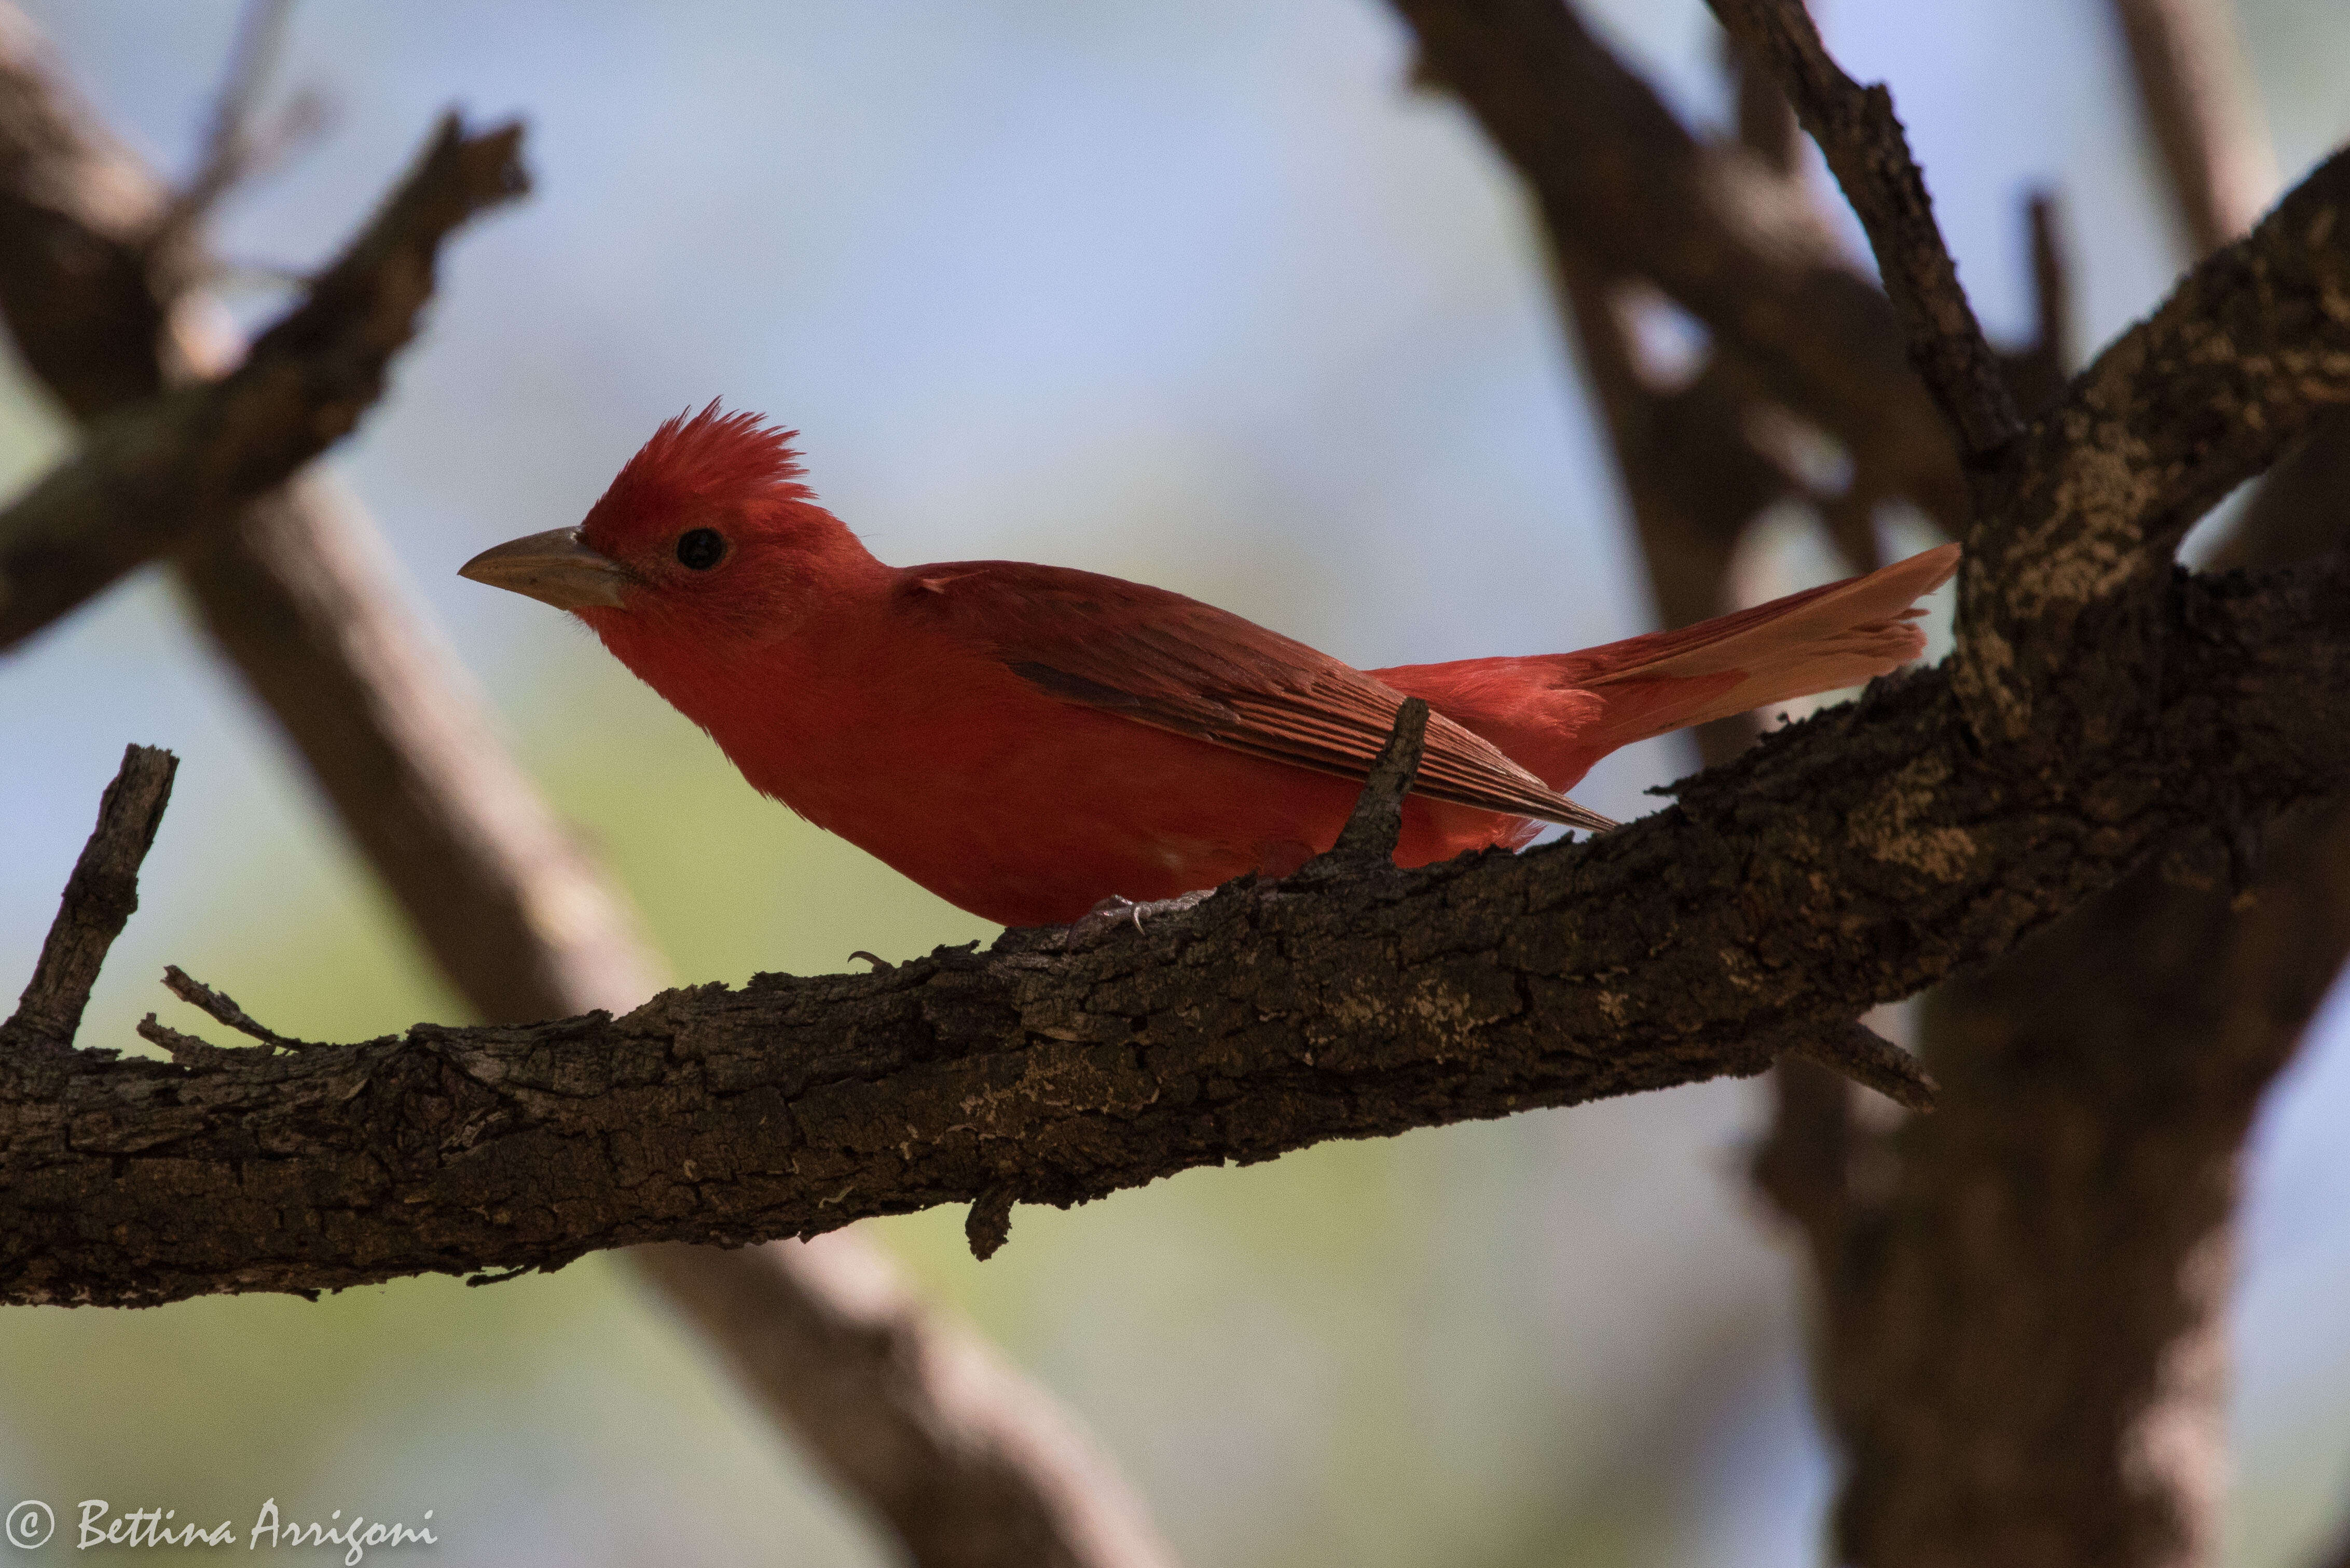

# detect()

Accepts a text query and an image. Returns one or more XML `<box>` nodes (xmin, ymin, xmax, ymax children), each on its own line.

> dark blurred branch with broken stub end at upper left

<box><xmin>0</xmin><ymin>115</ymin><xmax>526</xmax><ymax>649</ymax></box>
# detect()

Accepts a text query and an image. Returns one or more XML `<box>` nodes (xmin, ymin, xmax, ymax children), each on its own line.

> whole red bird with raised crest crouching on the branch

<box><xmin>463</xmin><ymin>402</ymin><xmax>1958</xmax><ymax>926</ymax></box>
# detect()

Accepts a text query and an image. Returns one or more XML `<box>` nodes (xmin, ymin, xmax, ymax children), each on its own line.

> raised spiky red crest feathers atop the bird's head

<box><xmin>581</xmin><ymin>397</ymin><xmax>816</xmax><ymax>548</ymax></box>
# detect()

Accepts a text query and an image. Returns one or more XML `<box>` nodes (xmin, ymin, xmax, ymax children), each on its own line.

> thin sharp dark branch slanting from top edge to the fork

<box><xmin>1709</xmin><ymin>0</ymin><xmax>2023</xmax><ymax>463</ymax></box>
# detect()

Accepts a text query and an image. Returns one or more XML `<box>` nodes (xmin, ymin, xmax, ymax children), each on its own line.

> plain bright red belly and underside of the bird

<box><xmin>743</xmin><ymin>698</ymin><xmax>1523</xmax><ymax>926</ymax></box>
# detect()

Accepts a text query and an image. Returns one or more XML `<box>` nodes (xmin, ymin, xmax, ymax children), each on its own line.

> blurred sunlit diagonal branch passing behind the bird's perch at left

<box><xmin>0</xmin><ymin>21</ymin><xmax>1175</xmax><ymax>1568</ymax></box>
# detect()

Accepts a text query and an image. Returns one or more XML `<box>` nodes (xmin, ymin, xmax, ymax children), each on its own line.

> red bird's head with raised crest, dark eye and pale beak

<box><xmin>458</xmin><ymin>400</ymin><xmax>872</xmax><ymax>663</ymax></box>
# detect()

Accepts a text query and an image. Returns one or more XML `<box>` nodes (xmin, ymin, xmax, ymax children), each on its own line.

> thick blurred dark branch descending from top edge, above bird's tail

<box><xmin>1394</xmin><ymin>0</ymin><xmax>1969</xmax><ymax>533</ymax></box>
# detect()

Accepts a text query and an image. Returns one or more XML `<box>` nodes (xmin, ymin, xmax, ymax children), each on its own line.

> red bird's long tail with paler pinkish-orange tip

<box><xmin>1372</xmin><ymin>545</ymin><xmax>1958</xmax><ymax>790</ymax></box>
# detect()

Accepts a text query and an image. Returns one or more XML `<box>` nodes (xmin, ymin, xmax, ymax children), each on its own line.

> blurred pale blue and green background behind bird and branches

<box><xmin>0</xmin><ymin>0</ymin><xmax>2350</xmax><ymax>1568</ymax></box>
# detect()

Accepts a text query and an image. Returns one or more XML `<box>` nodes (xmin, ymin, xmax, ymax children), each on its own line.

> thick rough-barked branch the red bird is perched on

<box><xmin>13</xmin><ymin>545</ymin><xmax>2350</xmax><ymax>1302</ymax></box>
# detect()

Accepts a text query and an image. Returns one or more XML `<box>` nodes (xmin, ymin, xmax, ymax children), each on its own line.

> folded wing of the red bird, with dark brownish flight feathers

<box><xmin>898</xmin><ymin>562</ymin><xmax>1614</xmax><ymax>832</ymax></box>
